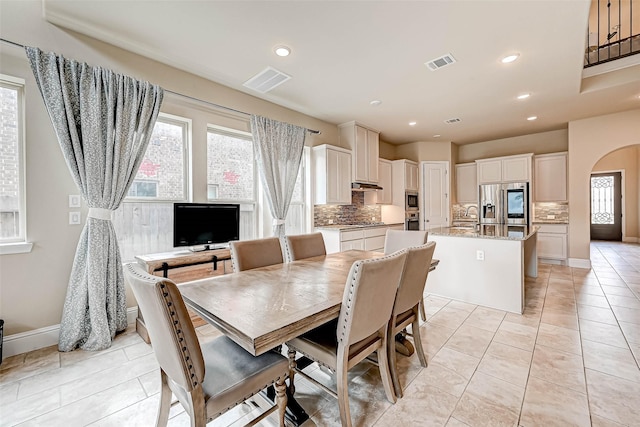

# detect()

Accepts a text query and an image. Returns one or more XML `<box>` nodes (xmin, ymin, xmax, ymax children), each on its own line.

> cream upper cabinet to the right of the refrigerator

<box><xmin>533</xmin><ymin>152</ymin><xmax>567</xmax><ymax>202</ymax></box>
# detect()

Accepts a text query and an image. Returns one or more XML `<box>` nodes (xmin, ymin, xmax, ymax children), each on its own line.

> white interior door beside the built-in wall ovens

<box><xmin>420</xmin><ymin>162</ymin><xmax>449</xmax><ymax>230</ymax></box>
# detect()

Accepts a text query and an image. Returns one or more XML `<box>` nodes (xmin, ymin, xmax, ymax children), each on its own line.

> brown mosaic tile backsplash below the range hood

<box><xmin>313</xmin><ymin>191</ymin><xmax>382</xmax><ymax>227</ymax></box>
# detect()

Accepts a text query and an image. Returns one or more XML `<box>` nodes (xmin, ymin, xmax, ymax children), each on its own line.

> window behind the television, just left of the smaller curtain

<box><xmin>207</xmin><ymin>126</ymin><xmax>258</xmax><ymax>240</ymax></box>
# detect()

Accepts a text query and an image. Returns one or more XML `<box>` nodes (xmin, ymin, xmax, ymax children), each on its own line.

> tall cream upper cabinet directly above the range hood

<box><xmin>339</xmin><ymin>122</ymin><xmax>380</xmax><ymax>184</ymax></box>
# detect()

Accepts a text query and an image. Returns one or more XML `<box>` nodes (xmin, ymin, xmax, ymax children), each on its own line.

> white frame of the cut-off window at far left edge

<box><xmin>0</xmin><ymin>74</ymin><xmax>33</xmax><ymax>255</ymax></box>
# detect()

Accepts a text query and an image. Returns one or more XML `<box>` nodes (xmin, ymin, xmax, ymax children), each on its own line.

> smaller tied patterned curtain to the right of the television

<box><xmin>251</xmin><ymin>115</ymin><xmax>307</xmax><ymax>238</ymax></box>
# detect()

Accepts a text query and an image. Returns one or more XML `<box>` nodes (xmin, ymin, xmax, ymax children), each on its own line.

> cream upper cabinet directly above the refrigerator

<box><xmin>476</xmin><ymin>153</ymin><xmax>533</xmax><ymax>184</ymax></box>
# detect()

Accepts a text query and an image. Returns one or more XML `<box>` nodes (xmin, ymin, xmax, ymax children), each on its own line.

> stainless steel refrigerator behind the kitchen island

<box><xmin>478</xmin><ymin>182</ymin><xmax>529</xmax><ymax>225</ymax></box>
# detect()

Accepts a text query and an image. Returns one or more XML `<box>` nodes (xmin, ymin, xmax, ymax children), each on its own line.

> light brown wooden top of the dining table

<box><xmin>178</xmin><ymin>250</ymin><xmax>437</xmax><ymax>356</ymax></box>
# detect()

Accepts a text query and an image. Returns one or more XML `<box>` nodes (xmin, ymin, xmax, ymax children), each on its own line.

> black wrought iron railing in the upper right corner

<box><xmin>584</xmin><ymin>0</ymin><xmax>640</xmax><ymax>68</ymax></box>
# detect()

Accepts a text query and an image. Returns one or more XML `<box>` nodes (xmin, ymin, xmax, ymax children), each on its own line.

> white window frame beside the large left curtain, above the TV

<box><xmin>122</xmin><ymin>112</ymin><xmax>193</xmax><ymax>203</ymax></box>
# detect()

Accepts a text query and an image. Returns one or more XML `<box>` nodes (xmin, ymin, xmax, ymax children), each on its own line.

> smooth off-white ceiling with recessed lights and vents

<box><xmin>43</xmin><ymin>0</ymin><xmax>640</xmax><ymax>144</ymax></box>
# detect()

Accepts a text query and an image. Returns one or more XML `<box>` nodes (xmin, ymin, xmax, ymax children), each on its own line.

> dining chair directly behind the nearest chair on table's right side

<box><xmin>387</xmin><ymin>242</ymin><xmax>436</xmax><ymax>397</ymax></box>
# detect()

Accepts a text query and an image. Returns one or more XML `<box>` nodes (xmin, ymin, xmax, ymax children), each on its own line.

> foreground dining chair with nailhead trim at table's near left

<box><xmin>124</xmin><ymin>263</ymin><xmax>290</xmax><ymax>426</ymax></box>
